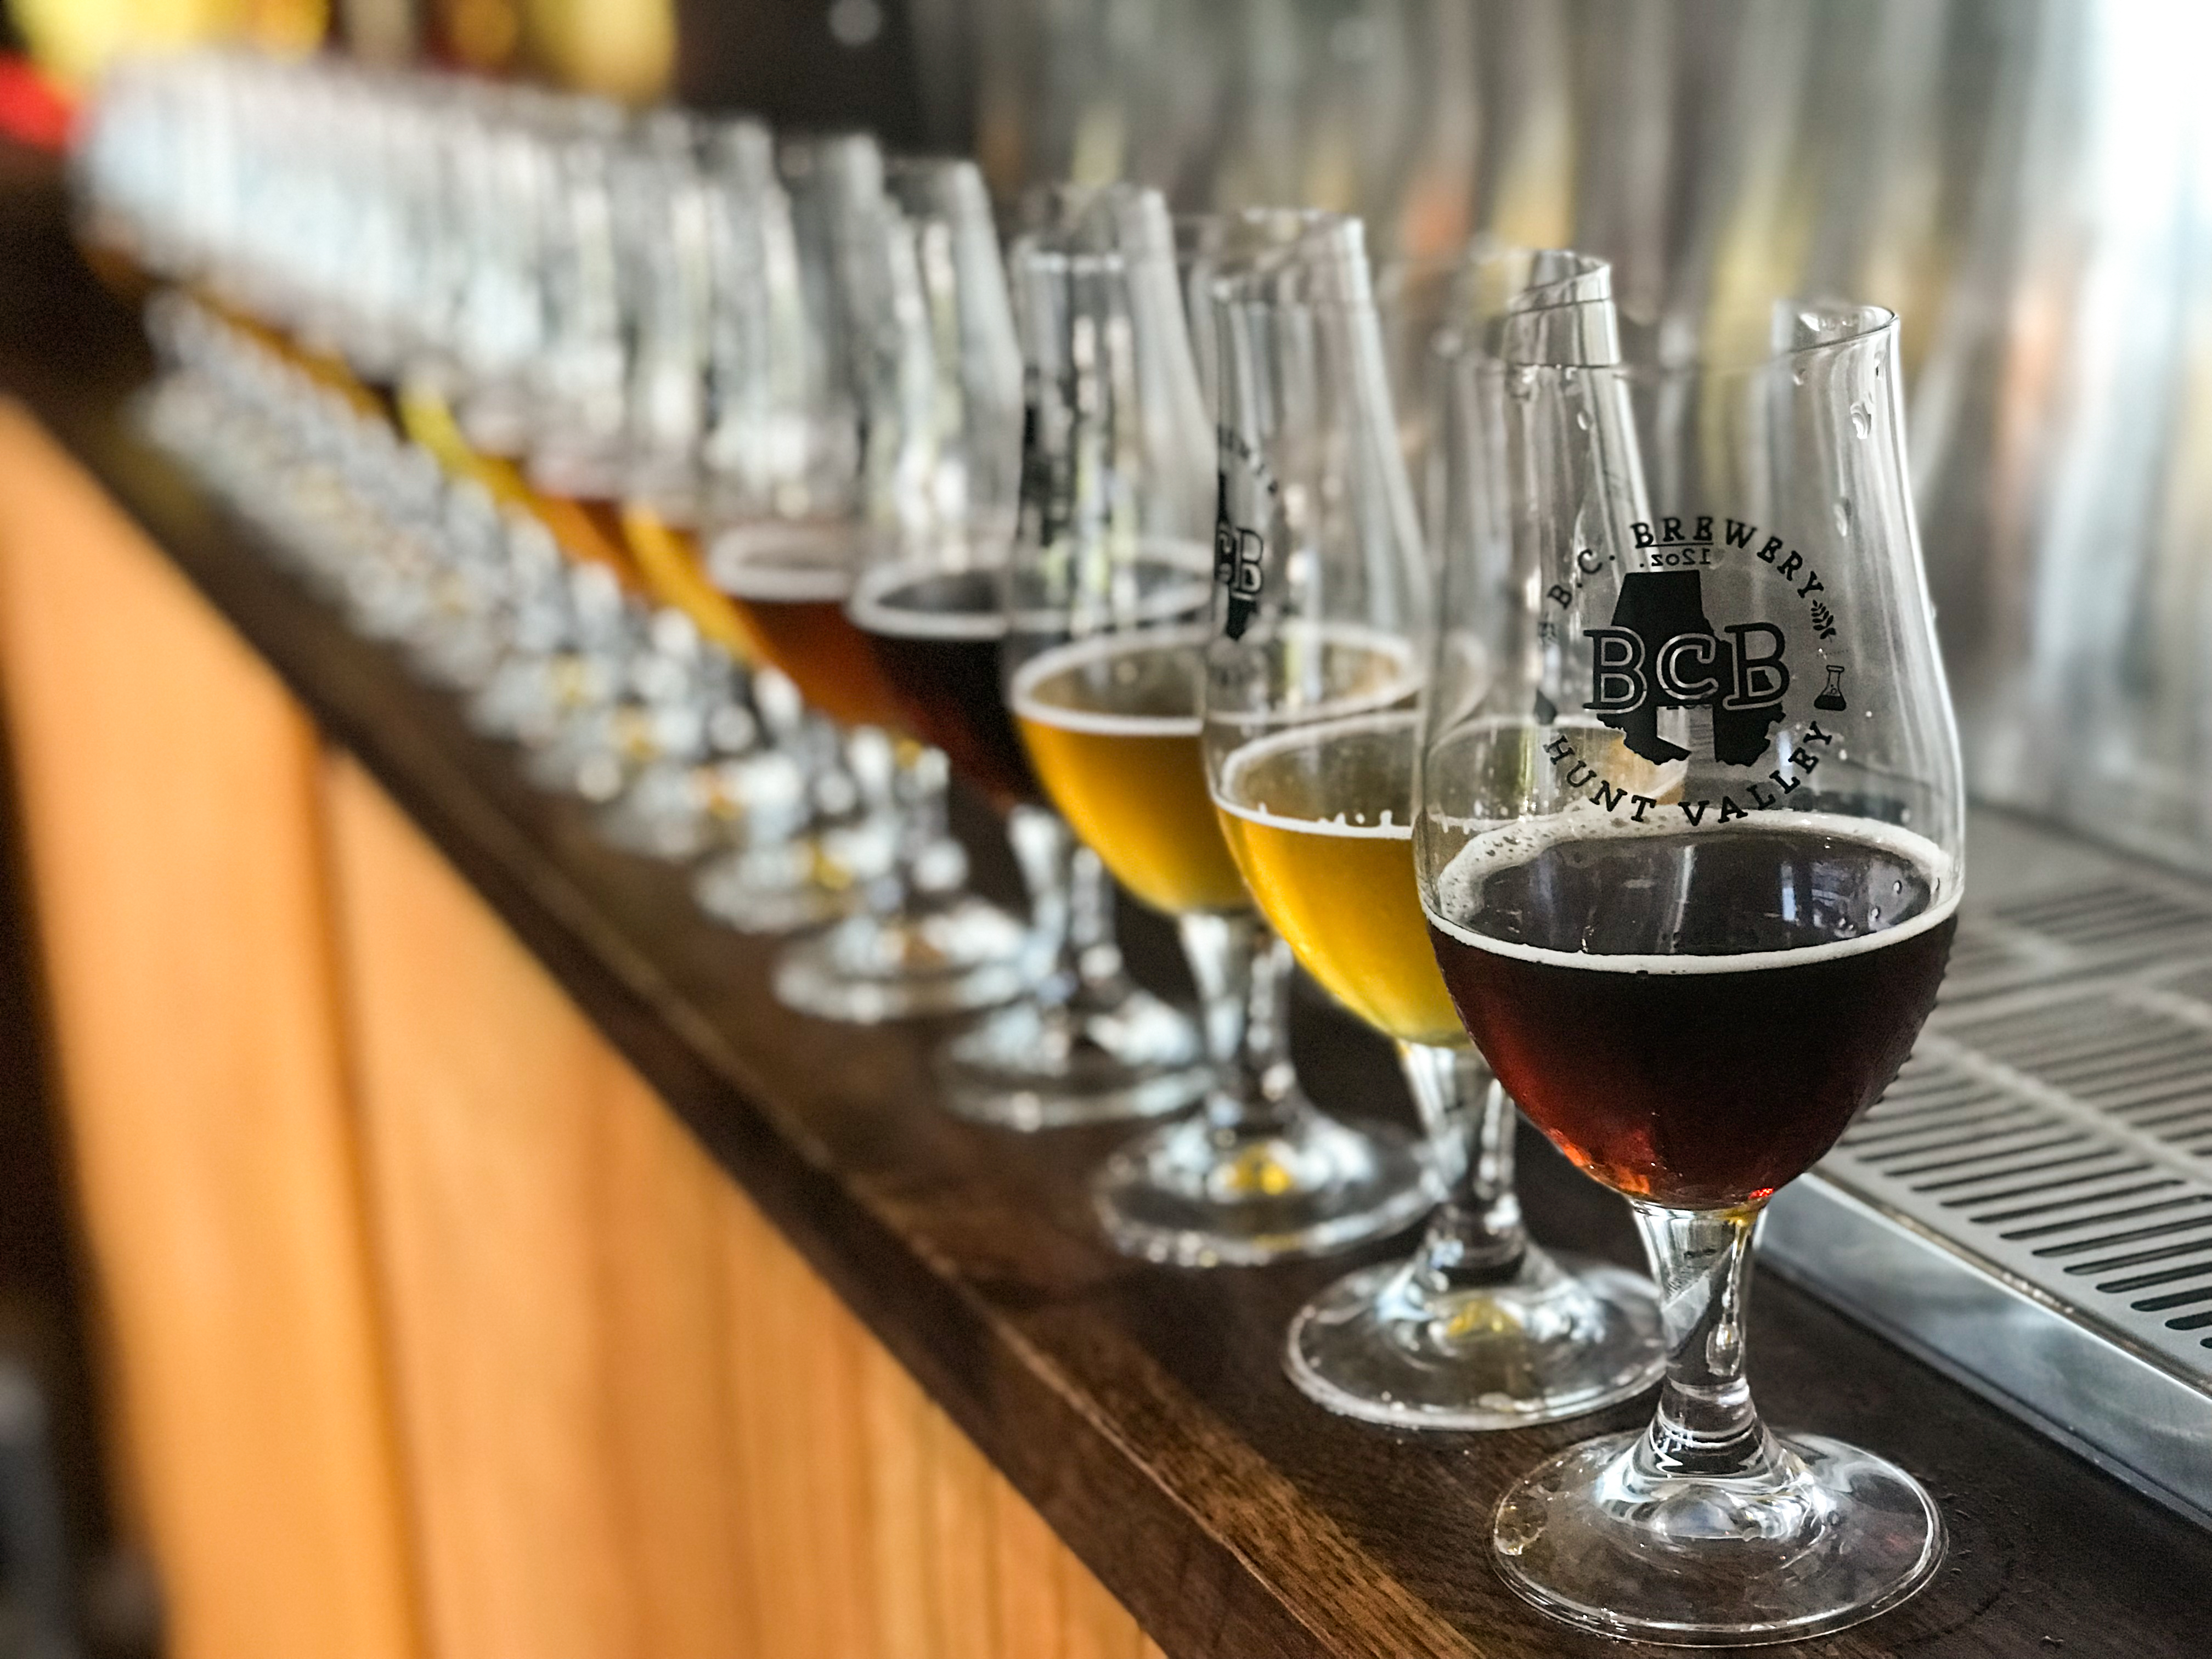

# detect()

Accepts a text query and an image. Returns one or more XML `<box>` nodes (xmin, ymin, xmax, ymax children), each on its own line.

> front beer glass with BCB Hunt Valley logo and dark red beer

<box><xmin>1413</xmin><ymin>283</ymin><xmax>1964</xmax><ymax>1646</ymax></box>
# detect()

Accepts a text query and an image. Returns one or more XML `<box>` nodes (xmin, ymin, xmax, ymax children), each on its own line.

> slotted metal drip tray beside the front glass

<box><xmin>1760</xmin><ymin>810</ymin><xmax>2212</xmax><ymax>1524</ymax></box>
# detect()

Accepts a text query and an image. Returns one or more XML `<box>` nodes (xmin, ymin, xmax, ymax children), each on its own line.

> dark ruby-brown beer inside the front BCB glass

<box><xmin>1434</xmin><ymin>814</ymin><xmax>1957</xmax><ymax>1207</ymax></box>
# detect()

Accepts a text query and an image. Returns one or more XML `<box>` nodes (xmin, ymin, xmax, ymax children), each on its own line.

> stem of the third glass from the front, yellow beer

<box><xmin>1179</xmin><ymin>911</ymin><xmax>1307</xmax><ymax>1135</ymax></box>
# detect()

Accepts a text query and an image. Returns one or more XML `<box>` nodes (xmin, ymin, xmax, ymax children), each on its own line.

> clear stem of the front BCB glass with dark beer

<box><xmin>1630</xmin><ymin>1203</ymin><xmax>1779</xmax><ymax>1477</ymax></box>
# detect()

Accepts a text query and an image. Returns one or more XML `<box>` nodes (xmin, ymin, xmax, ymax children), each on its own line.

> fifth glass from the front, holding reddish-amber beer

<box><xmin>734</xmin><ymin>135</ymin><xmax>1033</xmax><ymax>1022</ymax></box>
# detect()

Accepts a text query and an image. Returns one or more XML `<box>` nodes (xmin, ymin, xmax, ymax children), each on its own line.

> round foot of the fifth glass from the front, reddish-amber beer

<box><xmin>776</xmin><ymin>894</ymin><xmax>1035</xmax><ymax>1026</ymax></box>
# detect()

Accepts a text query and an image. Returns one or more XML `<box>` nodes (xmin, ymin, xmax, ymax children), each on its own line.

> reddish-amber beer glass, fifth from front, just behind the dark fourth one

<box><xmin>699</xmin><ymin>133</ymin><xmax>1033</xmax><ymax>1022</ymax></box>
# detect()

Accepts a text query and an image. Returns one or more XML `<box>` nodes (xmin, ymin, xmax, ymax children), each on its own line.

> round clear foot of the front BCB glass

<box><xmin>1496</xmin><ymin>1431</ymin><xmax>1944</xmax><ymax>1648</ymax></box>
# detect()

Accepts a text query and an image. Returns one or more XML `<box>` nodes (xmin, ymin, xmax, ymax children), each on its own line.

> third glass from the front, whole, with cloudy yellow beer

<box><xmin>1062</xmin><ymin>204</ymin><xmax>1436</xmax><ymax>1265</ymax></box>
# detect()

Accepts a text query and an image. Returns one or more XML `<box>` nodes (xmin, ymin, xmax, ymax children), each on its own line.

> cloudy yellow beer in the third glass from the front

<box><xmin>1011</xmin><ymin>628</ymin><xmax>1256</xmax><ymax>916</ymax></box>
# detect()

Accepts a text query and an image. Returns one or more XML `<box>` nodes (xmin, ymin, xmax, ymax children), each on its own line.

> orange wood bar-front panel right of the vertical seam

<box><xmin>330</xmin><ymin>761</ymin><xmax>1142</xmax><ymax>1659</ymax></box>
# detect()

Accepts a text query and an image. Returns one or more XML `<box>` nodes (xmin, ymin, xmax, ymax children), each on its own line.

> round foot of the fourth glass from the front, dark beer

<box><xmin>938</xmin><ymin>982</ymin><xmax>1215</xmax><ymax>1130</ymax></box>
